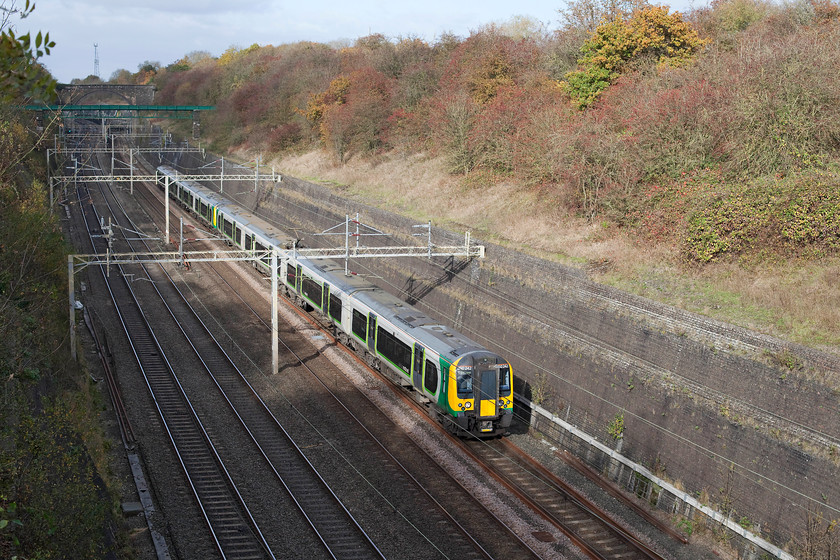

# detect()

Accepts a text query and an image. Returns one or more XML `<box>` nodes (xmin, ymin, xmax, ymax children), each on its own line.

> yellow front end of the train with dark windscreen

<box><xmin>447</xmin><ymin>352</ymin><xmax>513</xmax><ymax>437</ymax></box>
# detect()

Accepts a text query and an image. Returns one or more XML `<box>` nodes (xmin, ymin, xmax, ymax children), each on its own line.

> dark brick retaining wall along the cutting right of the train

<box><xmin>162</xmin><ymin>152</ymin><xmax>840</xmax><ymax>546</ymax></box>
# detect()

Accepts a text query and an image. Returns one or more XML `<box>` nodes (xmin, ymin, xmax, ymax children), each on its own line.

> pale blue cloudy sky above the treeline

<box><xmin>18</xmin><ymin>0</ymin><xmax>704</xmax><ymax>83</ymax></box>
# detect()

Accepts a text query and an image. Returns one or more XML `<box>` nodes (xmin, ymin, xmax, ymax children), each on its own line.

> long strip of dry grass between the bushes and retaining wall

<box><xmin>273</xmin><ymin>152</ymin><xmax>840</xmax><ymax>352</ymax></box>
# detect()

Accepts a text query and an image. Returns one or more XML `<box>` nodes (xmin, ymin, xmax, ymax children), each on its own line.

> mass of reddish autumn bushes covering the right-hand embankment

<box><xmin>151</xmin><ymin>0</ymin><xmax>840</xmax><ymax>256</ymax></box>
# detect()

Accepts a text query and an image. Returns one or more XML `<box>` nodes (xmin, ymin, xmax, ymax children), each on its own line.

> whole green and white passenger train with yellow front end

<box><xmin>158</xmin><ymin>166</ymin><xmax>513</xmax><ymax>437</ymax></box>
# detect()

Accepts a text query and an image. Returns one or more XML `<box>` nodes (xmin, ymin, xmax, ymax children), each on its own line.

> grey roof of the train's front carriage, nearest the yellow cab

<box><xmin>298</xmin><ymin>259</ymin><xmax>487</xmax><ymax>360</ymax></box>
